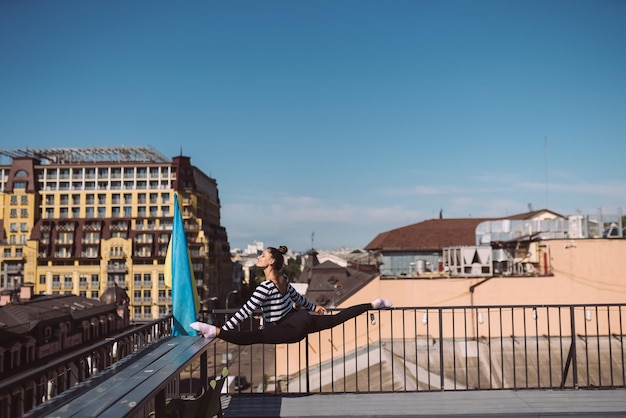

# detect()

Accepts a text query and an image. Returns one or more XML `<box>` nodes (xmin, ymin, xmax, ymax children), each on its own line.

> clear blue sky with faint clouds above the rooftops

<box><xmin>0</xmin><ymin>0</ymin><xmax>626</xmax><ymax>250</ymax></box>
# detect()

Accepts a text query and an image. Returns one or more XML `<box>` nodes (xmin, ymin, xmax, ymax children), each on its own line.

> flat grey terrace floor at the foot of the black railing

<box><xmin>224</xmin><ymin>389</ymin><xmax>626</xmax><ymax>418</ymax></box>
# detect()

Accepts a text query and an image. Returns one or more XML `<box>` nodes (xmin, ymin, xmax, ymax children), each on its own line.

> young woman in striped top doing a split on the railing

<box><xmin>191</xmin><ymin>246</ymin><xmax>391</xmax><ymax>345</ymax></box>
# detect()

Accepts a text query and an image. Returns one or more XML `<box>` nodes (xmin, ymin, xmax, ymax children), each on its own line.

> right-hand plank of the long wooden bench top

<box><xmin>98</xmin><ymin>337</ymin><xmax>211</xmax><ymax>418</ymax></box>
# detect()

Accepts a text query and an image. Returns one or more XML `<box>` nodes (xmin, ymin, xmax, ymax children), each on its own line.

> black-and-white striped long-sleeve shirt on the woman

<box><xmin>222</xmin><ymin>280</ymin><xmax>315</xmax><ymax>330</ymax></box>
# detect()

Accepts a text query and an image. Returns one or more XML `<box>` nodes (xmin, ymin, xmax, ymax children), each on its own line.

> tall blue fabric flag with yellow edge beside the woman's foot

<box><xmin>164</xmin><ymin>194</ymin><xmax>200</xmax><ymax>336</ymax></box>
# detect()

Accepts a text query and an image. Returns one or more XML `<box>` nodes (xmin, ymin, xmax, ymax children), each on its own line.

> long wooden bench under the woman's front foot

<box><xmin>45</xmin><ymin>337</ymin><xmax>214</xmax><ymax>418</ymax></box>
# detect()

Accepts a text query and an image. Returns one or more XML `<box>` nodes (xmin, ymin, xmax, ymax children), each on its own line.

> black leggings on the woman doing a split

<box><xmin>218</xmin><ymin>303</ymin><xmax>372</xmax><ymax>345</ymax></box>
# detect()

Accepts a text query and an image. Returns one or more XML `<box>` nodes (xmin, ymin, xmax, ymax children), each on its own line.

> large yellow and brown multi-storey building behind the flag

<box><xmin>0</xmin><ymin>147</ymin><xmax>232</xmax><ymax>321</ymax></box>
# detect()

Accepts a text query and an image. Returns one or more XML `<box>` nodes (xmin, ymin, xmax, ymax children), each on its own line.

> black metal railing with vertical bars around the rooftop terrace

<box><xmin>0</xmin><ymin>304</ymin><xmax>626</xmax><ymax>417</ymax></box>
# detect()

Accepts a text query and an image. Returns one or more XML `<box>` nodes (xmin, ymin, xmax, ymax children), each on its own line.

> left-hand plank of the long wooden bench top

<box><xmin>52</xmin><ymin>337</ymin><xmax>206</xmax><ymax>418</ymax></box>
